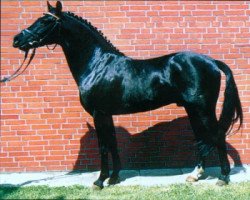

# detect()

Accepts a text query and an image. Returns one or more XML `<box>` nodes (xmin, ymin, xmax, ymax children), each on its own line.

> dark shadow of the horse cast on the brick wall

<box><xmin>72</xmin><ymin>117</ymin><xmax>245</xmax><ymax>176</ymax></box>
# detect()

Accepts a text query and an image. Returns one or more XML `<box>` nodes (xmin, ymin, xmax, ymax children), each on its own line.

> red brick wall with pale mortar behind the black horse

<box><xmin>0</xmin><ymin>1</ymin><xmax>250</xmax><ymax>172</ymax></box>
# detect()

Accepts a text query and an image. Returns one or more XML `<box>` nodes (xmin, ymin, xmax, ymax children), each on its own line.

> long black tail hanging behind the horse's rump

<box><xmin>216</xmin><ymin>60</ymin><xmax>243</xmax><ymax>134</ymax></box>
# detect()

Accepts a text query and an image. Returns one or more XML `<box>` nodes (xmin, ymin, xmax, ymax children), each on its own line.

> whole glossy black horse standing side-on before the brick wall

<box><xmin>9</xmin><ymin>1</ymin><xmax>243</xmax><ymax>188</ymax></box>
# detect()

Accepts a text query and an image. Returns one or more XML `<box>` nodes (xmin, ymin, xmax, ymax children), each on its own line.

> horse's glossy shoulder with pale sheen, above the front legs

<box><xmin>79</xmin><ymin>53</ymin><xmax>128</xmax><ymax>113</ymax></box>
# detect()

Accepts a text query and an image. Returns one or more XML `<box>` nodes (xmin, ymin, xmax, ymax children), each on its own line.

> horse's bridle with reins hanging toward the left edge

<box><xmin>0</xmin><ymin>12</ymin><xmax>61</xmax><ymax>82</ymax></box>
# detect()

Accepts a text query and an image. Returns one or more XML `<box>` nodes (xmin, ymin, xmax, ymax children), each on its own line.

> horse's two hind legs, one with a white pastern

<box><xmin>186</xmin><ymin>107</ymin><xmax>230</xmax><ymax>186</ymax></box>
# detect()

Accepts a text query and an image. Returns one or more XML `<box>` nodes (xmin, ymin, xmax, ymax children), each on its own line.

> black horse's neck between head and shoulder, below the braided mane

<box><xmin>60</xmin><ymin>15</ymin><xmax>119</xmax><ymax>84</ymax></box>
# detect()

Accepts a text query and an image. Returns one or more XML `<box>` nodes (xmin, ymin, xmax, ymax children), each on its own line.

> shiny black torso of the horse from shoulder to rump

<box><xmin>77</xmin><ymin>48</ymin><xmax>220</xmax><ymax>115</ymax></box>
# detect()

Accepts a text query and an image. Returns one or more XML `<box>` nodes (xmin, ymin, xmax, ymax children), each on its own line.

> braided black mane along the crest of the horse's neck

<box><xmin>66</xmin><ymin>11</ymin><xmax>124</xmax><ymax>55</ymax></box>
